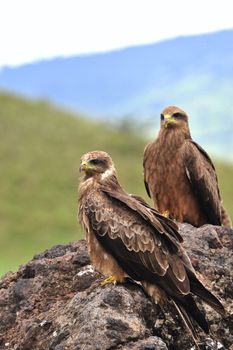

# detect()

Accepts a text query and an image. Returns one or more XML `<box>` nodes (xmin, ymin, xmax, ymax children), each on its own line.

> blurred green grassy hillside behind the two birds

<box><xmin>0</xmin><ymin>93</ymin><xmax>233</xmax><ymax>274</ymax></box>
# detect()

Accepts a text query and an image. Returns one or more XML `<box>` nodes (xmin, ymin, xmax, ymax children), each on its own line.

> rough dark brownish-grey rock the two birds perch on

<box><xmin>0</xmin><ymin>224</ymin><xmax>233</xmax><ymax>350</ymax></box>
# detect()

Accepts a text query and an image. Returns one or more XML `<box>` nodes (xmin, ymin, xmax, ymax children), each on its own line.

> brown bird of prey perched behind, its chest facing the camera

<box><xmin>143</xmin><ymin>106</ymin><xmax>231</xmax><ymax>227</ymax></box>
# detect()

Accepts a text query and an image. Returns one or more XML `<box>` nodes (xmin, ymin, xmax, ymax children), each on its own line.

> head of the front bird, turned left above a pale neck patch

<box><xmin>79</xmin><ymin>151</ymin><xmax>115</xmax><ymax>177</ymax></box>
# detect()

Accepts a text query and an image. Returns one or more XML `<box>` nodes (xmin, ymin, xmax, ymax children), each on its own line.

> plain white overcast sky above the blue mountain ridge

<box><xmin>0</xmin><ymin>0</ymin><xmax>233</xmax><ymax>66</ymax></box>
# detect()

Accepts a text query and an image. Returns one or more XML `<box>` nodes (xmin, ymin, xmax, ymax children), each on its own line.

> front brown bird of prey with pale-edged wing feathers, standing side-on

<box><xmin>78</xmin><ymin>151</ymin><xmax>224</xmax><ymax>338</ymax></box>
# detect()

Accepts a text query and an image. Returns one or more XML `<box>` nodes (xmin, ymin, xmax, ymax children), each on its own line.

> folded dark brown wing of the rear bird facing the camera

<box><xmin>181</xmin><ymin>140</ymin><xmax>221</xmax><ymax>225</ymax></box>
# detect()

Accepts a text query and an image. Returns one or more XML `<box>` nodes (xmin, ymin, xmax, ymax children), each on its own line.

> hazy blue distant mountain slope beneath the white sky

<box><xmin>0</xmin><ymin>30</ymin><xmax>233</xmax><ymax>159</ymax></box>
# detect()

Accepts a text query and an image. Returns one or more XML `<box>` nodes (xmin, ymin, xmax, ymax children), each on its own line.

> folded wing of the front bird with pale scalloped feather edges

<box><xmin>85</xmin><ymin>189</ymin><xmax>190</xmax><ymax>295</ymax></box>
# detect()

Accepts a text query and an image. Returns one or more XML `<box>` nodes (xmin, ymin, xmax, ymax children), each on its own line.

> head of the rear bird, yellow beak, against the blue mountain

<box><xmin>160</xmin><ymin>106</ymin><xmax>188</xmax><ymax>128</ymax></box>
